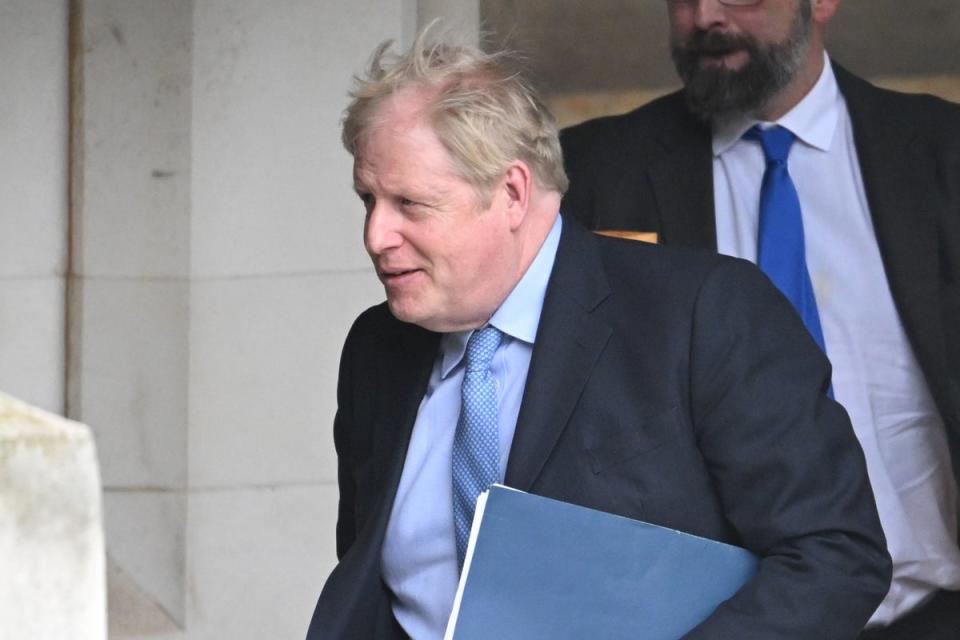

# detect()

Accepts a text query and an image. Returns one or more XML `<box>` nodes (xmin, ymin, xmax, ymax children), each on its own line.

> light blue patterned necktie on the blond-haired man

<box><xmin>453</xmin><ymin>326</ymin><xmax>503</xmax><ymax>568</ymax></box>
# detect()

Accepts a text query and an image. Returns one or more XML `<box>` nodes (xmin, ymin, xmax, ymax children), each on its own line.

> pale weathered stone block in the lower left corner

<box><xmin>0</xmin><ymin>393</ymin><xmax>106</xmax><ymax>640</ymax></box>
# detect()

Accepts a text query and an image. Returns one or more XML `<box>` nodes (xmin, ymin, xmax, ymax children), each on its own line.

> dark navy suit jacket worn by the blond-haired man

<box><xmin>308</xmin><ymin>219</ymin><xmax>890</xmax><ymax>640</ymax></box>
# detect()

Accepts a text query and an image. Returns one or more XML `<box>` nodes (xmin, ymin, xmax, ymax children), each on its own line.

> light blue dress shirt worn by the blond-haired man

<box><xmin>381</xmin><ymin>216</ymin><xmax>562</xmax><ymax>640</ymax></box>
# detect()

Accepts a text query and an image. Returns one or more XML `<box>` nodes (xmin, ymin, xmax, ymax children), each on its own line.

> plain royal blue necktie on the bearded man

<box><xmin>743</xmin><ymin>126</ymin><xmax>826</xmax><ymax>353</ymax></box>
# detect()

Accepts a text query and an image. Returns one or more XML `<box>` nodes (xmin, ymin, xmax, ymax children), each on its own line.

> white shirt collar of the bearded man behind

<box><xmin>713</xmin><ymin>52</ymin><xmax>843</xmax><ymax>157</ymax></box>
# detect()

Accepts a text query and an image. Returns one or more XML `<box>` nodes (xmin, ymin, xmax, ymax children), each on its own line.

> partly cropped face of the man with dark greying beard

<box><xmin>668</xmin><ymin>0</ymin><xmax>811</xmax><ymax>119</ymax></box>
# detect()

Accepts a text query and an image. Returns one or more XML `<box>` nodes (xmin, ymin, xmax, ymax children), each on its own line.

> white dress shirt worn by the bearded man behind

<box><xmin>713</xmin><ymin>55</ymin><xmax>960</xmax><ymax>626</ymax></box>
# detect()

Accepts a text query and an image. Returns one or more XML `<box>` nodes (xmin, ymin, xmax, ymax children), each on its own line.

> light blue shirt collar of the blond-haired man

<box><xmin>440</xmin><ymin>216</ymin><xmax>563</xmax><ymax>378</ymax></box>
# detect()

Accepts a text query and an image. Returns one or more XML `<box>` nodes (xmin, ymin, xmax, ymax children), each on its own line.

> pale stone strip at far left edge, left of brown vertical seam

<box><xmin>0</xmin><ymin>0</ymin><xmax>67</xmax><ymax>413</ymax></box>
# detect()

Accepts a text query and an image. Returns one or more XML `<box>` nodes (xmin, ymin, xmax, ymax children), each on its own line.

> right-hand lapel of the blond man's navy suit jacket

<box><xmin>505</xmin><ymin>219</ymin><xmax>611</xmax><ymax>491</ymax></box>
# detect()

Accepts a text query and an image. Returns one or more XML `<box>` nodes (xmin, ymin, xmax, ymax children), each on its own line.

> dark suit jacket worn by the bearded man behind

<box><xmin>560</xmin><ymin>62</ymin><xmax>960</xmax><ymax>492</ymax></box>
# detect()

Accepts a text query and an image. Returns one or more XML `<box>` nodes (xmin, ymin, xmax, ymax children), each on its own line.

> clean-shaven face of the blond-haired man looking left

<box><xmin>354</xmin><ymin>92</ymin><xmax>517</xmax><ymax>331</ymax></box>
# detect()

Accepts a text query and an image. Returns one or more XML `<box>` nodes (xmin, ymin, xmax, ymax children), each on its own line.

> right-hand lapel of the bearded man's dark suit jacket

<box><xmin>834</xmin><ymin>64</ymin><xmax>946</xmax><ymax>380</ymax></box>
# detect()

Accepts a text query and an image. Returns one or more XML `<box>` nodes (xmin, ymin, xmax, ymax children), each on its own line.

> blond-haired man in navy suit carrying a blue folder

<box><xmin>308</xmin><ymin>27</ymin><xmax>889</xmax><ymax>640</ymax></box>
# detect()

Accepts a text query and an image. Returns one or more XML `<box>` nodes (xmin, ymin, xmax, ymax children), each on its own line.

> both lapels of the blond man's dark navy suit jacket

<box><xmin>358</xmin><ymin>217</ymin><xmax>611</xmax><ymax>516</ymax></box>
